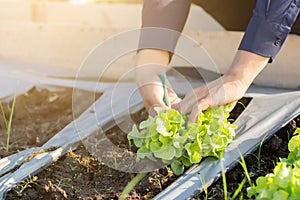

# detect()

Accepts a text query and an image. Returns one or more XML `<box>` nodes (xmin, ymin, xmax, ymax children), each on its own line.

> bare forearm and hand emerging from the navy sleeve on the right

<box><xmin>176</xmin><ymin>50</ymin><xmax>269</xmax><ymax>122</ymax></box>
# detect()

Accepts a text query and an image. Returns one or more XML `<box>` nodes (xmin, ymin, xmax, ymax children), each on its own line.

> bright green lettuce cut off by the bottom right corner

<box><xmin>247</xmin><ymin>128</ymin><xmax>300</xmax><ymax>200</ymax></box>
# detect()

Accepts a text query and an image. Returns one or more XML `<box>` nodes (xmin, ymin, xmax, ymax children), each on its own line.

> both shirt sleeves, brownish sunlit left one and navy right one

<box><xmin>139</xmin><ymin>0</ymin><xmax>300</xmax><ymax>62</ymax></box>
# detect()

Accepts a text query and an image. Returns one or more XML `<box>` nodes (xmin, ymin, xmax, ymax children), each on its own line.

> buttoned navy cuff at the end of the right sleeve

<box><xmin>239</xmin><ymin>16</ymin><xmax>290</xmax><ymax>62</ymax></box>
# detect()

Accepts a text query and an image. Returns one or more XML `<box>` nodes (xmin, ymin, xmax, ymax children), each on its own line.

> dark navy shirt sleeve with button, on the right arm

<box><xmin>239</xmin><ymin>0</ymin><xmax>300</xmax><ymax>62</ymax></box>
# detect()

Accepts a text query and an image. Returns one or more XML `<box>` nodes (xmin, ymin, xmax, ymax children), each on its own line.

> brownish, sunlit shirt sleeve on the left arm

<box><xmin>138</xmin><ymin>0</ymin><xmax>191</xmax><ymax>52</ymax></box>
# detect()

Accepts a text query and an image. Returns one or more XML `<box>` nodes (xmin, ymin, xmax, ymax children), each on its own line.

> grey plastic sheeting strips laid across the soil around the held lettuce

<box><xmin>0</xmin><ymin>61</ymin><xmax>300</xmax><ymax>199</ymax></box>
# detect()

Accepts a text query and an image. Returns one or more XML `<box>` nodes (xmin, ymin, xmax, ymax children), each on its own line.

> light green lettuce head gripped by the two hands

<box><xmin>127</xmin><ymin>105</ymin><xmax>236</xmax><ymax>175</ymax></box>
